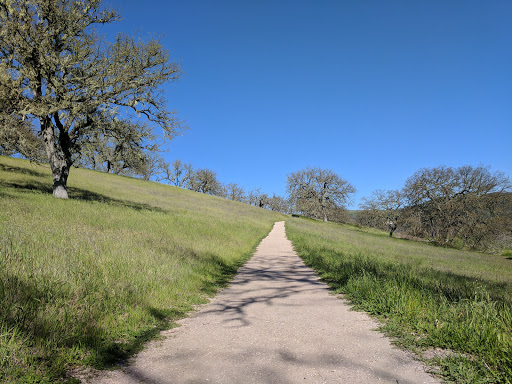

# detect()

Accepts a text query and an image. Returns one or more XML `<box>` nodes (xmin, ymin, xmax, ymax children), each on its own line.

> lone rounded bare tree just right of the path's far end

<box><xmin>287</xmin><ymin>167</ymin><xmax>356</xmax><ymax>222</ymax></box>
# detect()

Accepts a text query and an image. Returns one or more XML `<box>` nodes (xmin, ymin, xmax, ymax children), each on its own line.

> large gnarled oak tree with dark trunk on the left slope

<box><xmin>0</xmin><ymin>0</ymin><xmax>181</xmax><ymax>198</ymax></box>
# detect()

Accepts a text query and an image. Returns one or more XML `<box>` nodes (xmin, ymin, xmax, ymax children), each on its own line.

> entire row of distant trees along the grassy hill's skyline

<box><xmin>0</xmin><ymin>120</ymin><xmax>512</xmax><ymax>250</ymax></box>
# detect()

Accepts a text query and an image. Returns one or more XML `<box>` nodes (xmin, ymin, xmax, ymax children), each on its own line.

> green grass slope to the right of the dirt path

<box><xmin>286</xmin><ymin>219</ymin><xmax>512</xmax><ymax>383</ymax></box>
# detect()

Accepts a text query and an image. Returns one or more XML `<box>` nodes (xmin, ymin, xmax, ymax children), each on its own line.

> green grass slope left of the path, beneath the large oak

<box><xmin>0</xmin><ymin>157</ymin><xmax>285</xmax><ymax>383</ymax></box>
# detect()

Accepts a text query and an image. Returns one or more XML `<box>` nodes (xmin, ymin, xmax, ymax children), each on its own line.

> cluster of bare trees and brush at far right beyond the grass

<box><xmin>357</xmin><ymin>165</ymin><xmax>512</xmax><ymax>250</ymax></box>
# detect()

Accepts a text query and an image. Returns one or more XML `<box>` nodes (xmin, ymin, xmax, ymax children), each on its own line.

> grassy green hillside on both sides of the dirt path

<box><xmin>4</xmin><ymin>157</ymin><xmax>512</xmax><ymax>383</ymax></box>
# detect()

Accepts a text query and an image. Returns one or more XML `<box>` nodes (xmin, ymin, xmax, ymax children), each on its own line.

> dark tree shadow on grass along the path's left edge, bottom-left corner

<box><xmin>0</xmin><ymin>242</ymin><xmax>260</xmax><ymax>380</ymax></box>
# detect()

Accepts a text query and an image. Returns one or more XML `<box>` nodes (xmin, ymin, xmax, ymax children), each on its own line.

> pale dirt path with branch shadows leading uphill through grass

<box><xmin>88</xmin><ymin>222</ymin><xmax>439</xmax><ymax>384</ymax></box>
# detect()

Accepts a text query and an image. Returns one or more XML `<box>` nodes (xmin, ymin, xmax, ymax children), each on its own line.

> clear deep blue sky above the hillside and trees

<box><xmin>102</xmin><ymin>0</ymin><xmax>512</xmax><ymax>208</ymax></box>
